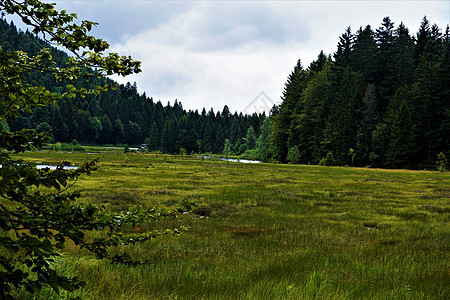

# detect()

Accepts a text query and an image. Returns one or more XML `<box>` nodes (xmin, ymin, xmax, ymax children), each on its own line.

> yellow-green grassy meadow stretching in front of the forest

<box><xmin>12</xmin><ymin>151</ymin><xmax>450</xmax><ymax>299</ymax></box>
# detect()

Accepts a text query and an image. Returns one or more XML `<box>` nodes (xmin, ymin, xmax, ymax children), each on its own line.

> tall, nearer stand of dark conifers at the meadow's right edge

<box><xmin>272</xmin><ymin>17</ymin><xmax>450</xmax><ymax>168</ymax></box>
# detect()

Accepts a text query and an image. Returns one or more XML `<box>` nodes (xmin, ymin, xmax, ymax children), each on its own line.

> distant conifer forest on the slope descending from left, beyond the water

<box><xmin>0</xmin><ymin>19</ymin><xmax>266</xmax><ymax>153</ymax></box>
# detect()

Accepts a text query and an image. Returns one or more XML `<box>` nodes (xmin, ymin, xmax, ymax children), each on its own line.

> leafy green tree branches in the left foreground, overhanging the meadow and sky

<box><xmin>0</xmin><ymin>0</ymin><xmax>189</xmax><ymax>299</ymax></box>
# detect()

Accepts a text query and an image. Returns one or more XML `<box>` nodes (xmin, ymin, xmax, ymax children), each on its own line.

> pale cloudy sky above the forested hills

<box><xmin>6</xmin><ymin>0</ymin><xmax>450</xmax><ymax>113</ymax></box>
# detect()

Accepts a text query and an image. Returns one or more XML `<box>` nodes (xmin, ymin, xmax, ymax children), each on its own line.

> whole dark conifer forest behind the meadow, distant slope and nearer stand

<box><xmin>0</xmin><ymin>17</ymin><xmax>450</xmax><ymax>169</ymax></box>
